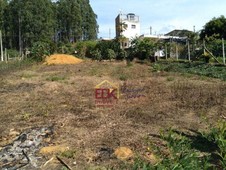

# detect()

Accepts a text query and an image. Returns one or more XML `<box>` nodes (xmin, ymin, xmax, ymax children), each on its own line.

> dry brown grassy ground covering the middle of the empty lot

<box><xmin>0</xmin><ymin>61</ymin><xmax>226</xmax><ymax>169</ymax></box>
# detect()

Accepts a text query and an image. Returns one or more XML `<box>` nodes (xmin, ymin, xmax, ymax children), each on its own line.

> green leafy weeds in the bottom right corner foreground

<box><xmin>119</xmin><ymin>121</ymin><xmax>226</xmax><ymax>170</ymax></box>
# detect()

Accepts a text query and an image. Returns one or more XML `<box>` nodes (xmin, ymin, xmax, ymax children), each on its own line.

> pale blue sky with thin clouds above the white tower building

<box><xmin>90</xmin><ymin>0</ymin><xmax>226</xmax><ymax>38</ymax></box>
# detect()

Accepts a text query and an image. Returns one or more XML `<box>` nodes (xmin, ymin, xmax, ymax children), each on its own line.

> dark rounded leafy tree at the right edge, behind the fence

<box><xmin>200</xmin><ymin>15</ymin><xmax>226</xmax><ymax>39</ymax></box>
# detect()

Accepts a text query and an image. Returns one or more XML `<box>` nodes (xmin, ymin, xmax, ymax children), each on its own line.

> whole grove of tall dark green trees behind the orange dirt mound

<box><xmin>0</xmin><ymin>0</ymin><xmax>97</xmax><ymax>60</ymax></box>
